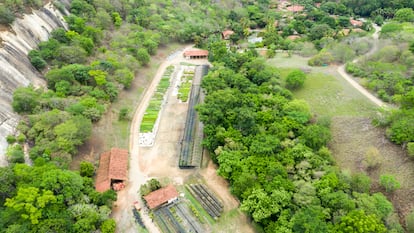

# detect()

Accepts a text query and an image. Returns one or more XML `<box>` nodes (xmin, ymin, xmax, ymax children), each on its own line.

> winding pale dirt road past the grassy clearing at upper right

<box><xmin>338</xmin><ymin>24</ymin><xmax>389</xmax><ymax>107</ymax></box>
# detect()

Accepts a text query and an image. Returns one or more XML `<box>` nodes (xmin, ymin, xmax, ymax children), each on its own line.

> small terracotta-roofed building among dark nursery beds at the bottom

<box><xmin>144</xmin><ymin>184</ymin><xmax>178</xmax><ymax>209</ymax></box>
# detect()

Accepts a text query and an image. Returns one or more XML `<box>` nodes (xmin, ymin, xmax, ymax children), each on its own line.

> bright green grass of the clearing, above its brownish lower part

<box><xmin>268</xmin><ymin>54</ymin><xmax>377</xmax><ymax>117</ymax></box>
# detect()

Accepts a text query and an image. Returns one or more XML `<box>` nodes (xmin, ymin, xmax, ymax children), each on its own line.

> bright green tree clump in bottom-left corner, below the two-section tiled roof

<box><xmin>0</xmin><ymin>163</ymin><xmax>114</xmax><ymax>232</ymax></box>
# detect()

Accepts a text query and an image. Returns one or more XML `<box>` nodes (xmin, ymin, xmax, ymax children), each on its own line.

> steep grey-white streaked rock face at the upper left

<box><xmin>0</xmin><ymin>0</ymin><xmax>68</xmax><ymax>166</ymax></box>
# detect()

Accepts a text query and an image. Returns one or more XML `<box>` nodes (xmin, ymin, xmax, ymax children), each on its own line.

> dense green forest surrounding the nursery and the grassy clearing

<box><xmin>0</xmin><ymin>0</ymin><xmax>414</xmax><ymax>232</ymax></box>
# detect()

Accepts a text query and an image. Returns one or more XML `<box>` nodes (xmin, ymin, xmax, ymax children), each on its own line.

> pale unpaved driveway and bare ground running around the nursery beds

<box><xmin>112</xmin><ymin>46</ymin><xmax>254</xmax><ymax>233</ymax></box>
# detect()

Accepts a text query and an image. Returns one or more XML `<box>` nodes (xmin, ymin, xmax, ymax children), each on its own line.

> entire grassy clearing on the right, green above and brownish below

<box><xmin>268</xmin><ymin>54</ymin><xmax>414</xmax><ymax>222</ymax></box>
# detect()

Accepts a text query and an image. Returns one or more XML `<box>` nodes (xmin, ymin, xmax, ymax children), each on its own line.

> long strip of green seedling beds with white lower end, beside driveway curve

<box><xmin>139</xmin><ymin>66</ymin><xmax>174</xmax><ymax>146</ymax></box>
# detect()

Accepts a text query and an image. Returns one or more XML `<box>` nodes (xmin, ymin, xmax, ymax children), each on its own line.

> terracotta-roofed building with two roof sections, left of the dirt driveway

<box><xmin>95</xmin><ymin>148</ymin><xmax>128</xmax><ymax>192</ymax></box>
